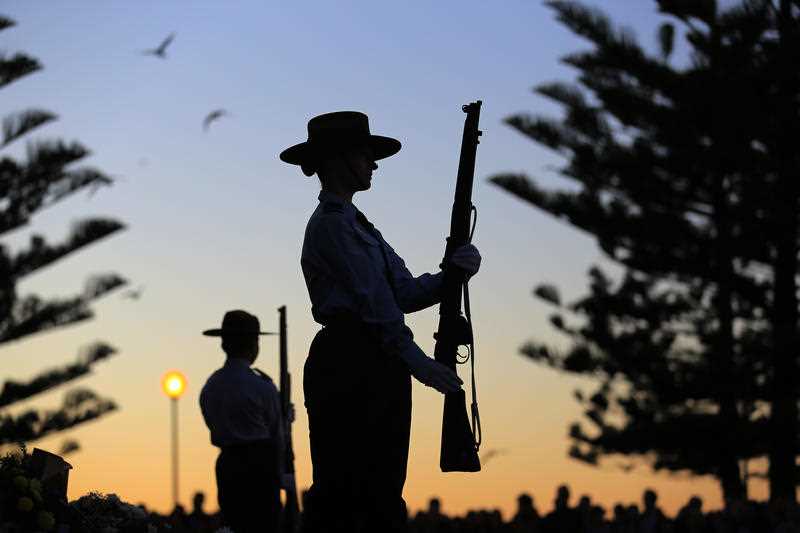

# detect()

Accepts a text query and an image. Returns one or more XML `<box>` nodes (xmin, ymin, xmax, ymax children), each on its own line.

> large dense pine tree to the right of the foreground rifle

<box><xmin>492</xmin><ymin>0</ymin><xmax>800</xmax><ymax>500</ymax></box>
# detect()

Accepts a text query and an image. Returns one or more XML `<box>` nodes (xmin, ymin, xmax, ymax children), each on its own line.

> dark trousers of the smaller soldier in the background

<box><xmin>216</xmin><ymin>441</ymin><xmax>281</xmax><ymax>533</ymax></box>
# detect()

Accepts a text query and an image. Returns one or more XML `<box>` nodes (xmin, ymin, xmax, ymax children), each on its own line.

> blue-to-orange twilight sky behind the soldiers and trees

<box><xmin>0</xmin><ymin>0</ymin><xmax>765</xmax><ymax>517</ymax></box>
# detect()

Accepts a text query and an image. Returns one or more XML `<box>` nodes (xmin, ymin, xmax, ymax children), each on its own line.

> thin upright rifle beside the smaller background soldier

<box><xmin>278</xmin><ymin>305</ymin><xmax>300</xmax><ymax>533</ymax></box>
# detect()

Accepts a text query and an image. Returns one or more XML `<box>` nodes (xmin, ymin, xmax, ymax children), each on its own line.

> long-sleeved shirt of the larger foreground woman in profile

<box><xmin>300</xmin><ymin>191</ymin><xmax>442</xmax><ymax>368</ymax></box>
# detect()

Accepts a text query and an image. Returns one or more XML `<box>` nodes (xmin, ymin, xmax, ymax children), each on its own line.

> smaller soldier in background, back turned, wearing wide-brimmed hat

<box><xmin>200</xmin><ymin>310</ymin><xmax>284</xmax><ymax>533</ymax></box>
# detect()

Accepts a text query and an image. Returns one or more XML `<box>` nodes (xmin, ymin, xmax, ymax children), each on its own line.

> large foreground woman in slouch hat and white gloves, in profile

<box><xmin>280</xmin><ymin>111</ymin><xmax>480</xmax><ymax>533</ymax></box>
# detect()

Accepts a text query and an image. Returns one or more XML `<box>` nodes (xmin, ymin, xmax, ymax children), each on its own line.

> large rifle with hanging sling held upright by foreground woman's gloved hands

<box><xmin>433</xmin><ymin>100</ymin><xmax>481</xmax><ymax>472</ymax></box>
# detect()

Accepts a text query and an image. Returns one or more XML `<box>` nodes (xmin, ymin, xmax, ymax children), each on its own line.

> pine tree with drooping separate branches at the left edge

<box><xmin>0</xmin><ymin>16</ymin><xmax>126</xmax><ymax>450</ymax></box>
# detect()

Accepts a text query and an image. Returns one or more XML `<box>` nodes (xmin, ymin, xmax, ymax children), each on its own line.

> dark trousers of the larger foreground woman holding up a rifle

<box><xmin>303</xmin><ymin>322</ymin><xmax>411</xmax><ymax>533</ymax></box>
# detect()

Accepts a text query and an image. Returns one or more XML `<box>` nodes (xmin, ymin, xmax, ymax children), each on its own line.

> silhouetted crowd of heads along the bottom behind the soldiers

<box><xmin>139</xmin><ymin>485</ymin><xmax>800</xmax><ymax>533</ymax></box>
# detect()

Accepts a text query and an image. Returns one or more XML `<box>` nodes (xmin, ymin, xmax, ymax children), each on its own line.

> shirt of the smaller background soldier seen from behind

<box><xmin>200</xmin><ymin>358</ymin><xmax>283</xmax><ymax>448</ymax></box>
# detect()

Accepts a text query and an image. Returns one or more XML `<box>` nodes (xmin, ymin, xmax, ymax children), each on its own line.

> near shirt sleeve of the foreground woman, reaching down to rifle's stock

<box><xmin>314</xmin><ymin>213</ymin><xmax>427</xmax><ymax>368</ymax></box>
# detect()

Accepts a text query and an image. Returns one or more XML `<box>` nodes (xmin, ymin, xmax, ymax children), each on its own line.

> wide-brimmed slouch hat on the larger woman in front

<box><xmin>280</xmin><ymin>111</ymin><xmax>401</xmax><ymax>176</ymax></box>
